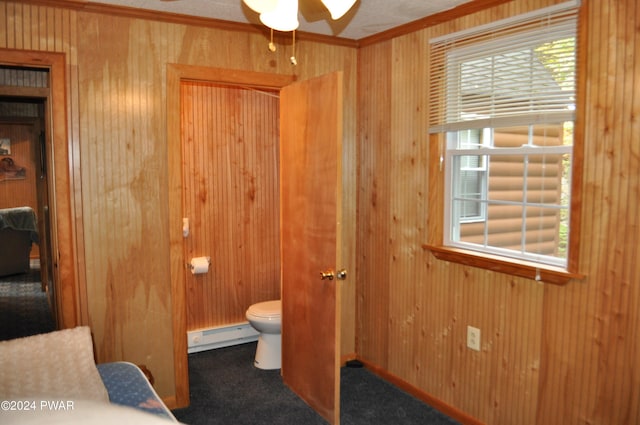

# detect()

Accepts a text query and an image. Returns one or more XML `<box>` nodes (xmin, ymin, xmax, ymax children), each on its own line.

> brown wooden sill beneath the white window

<box><xmin>422</xmin><ymin>245</ymin><xmax>584</xmax><ymax>285</ymax></box>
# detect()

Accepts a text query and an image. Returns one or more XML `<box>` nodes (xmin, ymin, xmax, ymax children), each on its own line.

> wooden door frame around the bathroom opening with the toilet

<box><xmin>167</xmin><ymin>64</ymin><xmax>295</xmax><ymax>407</ymax></box>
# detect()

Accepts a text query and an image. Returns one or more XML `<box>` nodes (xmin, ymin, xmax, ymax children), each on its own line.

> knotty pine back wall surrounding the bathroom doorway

<box><xmin>0</xmin><ymin>0</ymin><xmax>357</xmax><ymax>402</ymax></box>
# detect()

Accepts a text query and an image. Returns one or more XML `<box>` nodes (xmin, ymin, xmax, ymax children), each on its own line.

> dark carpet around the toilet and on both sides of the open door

<box><xmin>174</xmin><ymin>343</ymin><xmax>457</xmax><ymax>425</ymax></box>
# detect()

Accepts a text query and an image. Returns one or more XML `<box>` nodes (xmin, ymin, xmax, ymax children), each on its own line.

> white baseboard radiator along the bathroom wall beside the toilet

<box><xmin>187</xmin><ymin>322</ymin><xmax>258</xmax><ymax>354</ymax></box>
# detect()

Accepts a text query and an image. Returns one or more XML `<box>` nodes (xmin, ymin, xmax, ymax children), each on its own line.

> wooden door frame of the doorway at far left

<box><xmin>0</xmin><ymin>49</ymin><xmax>80</xmax><ymax>329</ymax></box>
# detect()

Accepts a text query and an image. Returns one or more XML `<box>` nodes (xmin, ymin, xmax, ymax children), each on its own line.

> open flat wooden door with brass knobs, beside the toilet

<box><xmin>280</xmin><ymin>72</ymin><xmax>342</xmax><ymax>424</ymax></box>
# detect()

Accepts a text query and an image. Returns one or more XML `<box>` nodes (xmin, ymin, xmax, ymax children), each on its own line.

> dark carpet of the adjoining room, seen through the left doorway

<box><xmin>0</xmin><ymin>269</ymin><xmax>55</xmax><ymax>341</ymax></box>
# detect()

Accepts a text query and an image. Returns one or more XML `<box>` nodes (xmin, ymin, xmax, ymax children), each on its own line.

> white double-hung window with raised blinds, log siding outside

<box><xmin>429</xmin><ymin>2</ymin><xmax>578</xmax><ymax>278</ymax></box>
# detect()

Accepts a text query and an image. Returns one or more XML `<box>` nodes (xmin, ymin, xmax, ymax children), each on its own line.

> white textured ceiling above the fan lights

<box><xmin>89</xmin><ymin>0</ymin><xmax>472</xmax><ymax>40</ymax></box>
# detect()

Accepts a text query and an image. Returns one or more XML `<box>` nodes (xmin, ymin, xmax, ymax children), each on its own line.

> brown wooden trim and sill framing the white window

<box><xmin>423</xmin><ymin>4</ymin><xmax>586</xmax><ymax>285</ymax></box>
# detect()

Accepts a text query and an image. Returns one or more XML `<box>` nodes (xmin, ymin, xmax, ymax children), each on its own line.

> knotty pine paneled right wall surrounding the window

<box><xmin>357</xmin><ymin>0</ymin><xmax>640</xmax><ymax>425</ymax></box>
